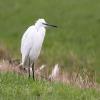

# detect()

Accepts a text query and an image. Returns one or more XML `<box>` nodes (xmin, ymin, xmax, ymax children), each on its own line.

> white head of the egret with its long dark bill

<box><xmin>35</xmin><ymin>19</ymin><xmax>57</xmax><ymax>28</ymax></box>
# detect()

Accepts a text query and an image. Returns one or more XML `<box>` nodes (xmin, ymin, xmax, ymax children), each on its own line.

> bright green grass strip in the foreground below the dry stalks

<box><xmin>0</xmin><ymin>73</ymin><xmax>100</xmax><ymax>100</ymax></box>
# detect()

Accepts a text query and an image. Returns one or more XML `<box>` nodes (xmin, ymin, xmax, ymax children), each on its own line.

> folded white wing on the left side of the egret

<box><xmin>21</xmin><ymin>26</ymin><xmax>35</xmax><ymax>56</ymax></box>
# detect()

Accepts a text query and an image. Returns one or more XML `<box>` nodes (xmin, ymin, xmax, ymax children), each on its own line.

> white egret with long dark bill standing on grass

<box><xmin>21</xmin><ymin>19</ymin><xmax>57</xmax><ymax>80</ymax></box>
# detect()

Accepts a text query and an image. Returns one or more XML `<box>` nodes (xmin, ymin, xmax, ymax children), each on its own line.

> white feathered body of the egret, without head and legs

<box><xmin>21</xmin><ymin>20</ymin><xmax>45</xmax><ymax>67</ymax></box>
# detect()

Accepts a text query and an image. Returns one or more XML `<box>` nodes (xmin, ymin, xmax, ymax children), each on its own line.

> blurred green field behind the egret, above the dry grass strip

<box><xmin>0</xmin><ymin>0</ymin><xmax>100</xmax><ymax>80</ymax></box>
